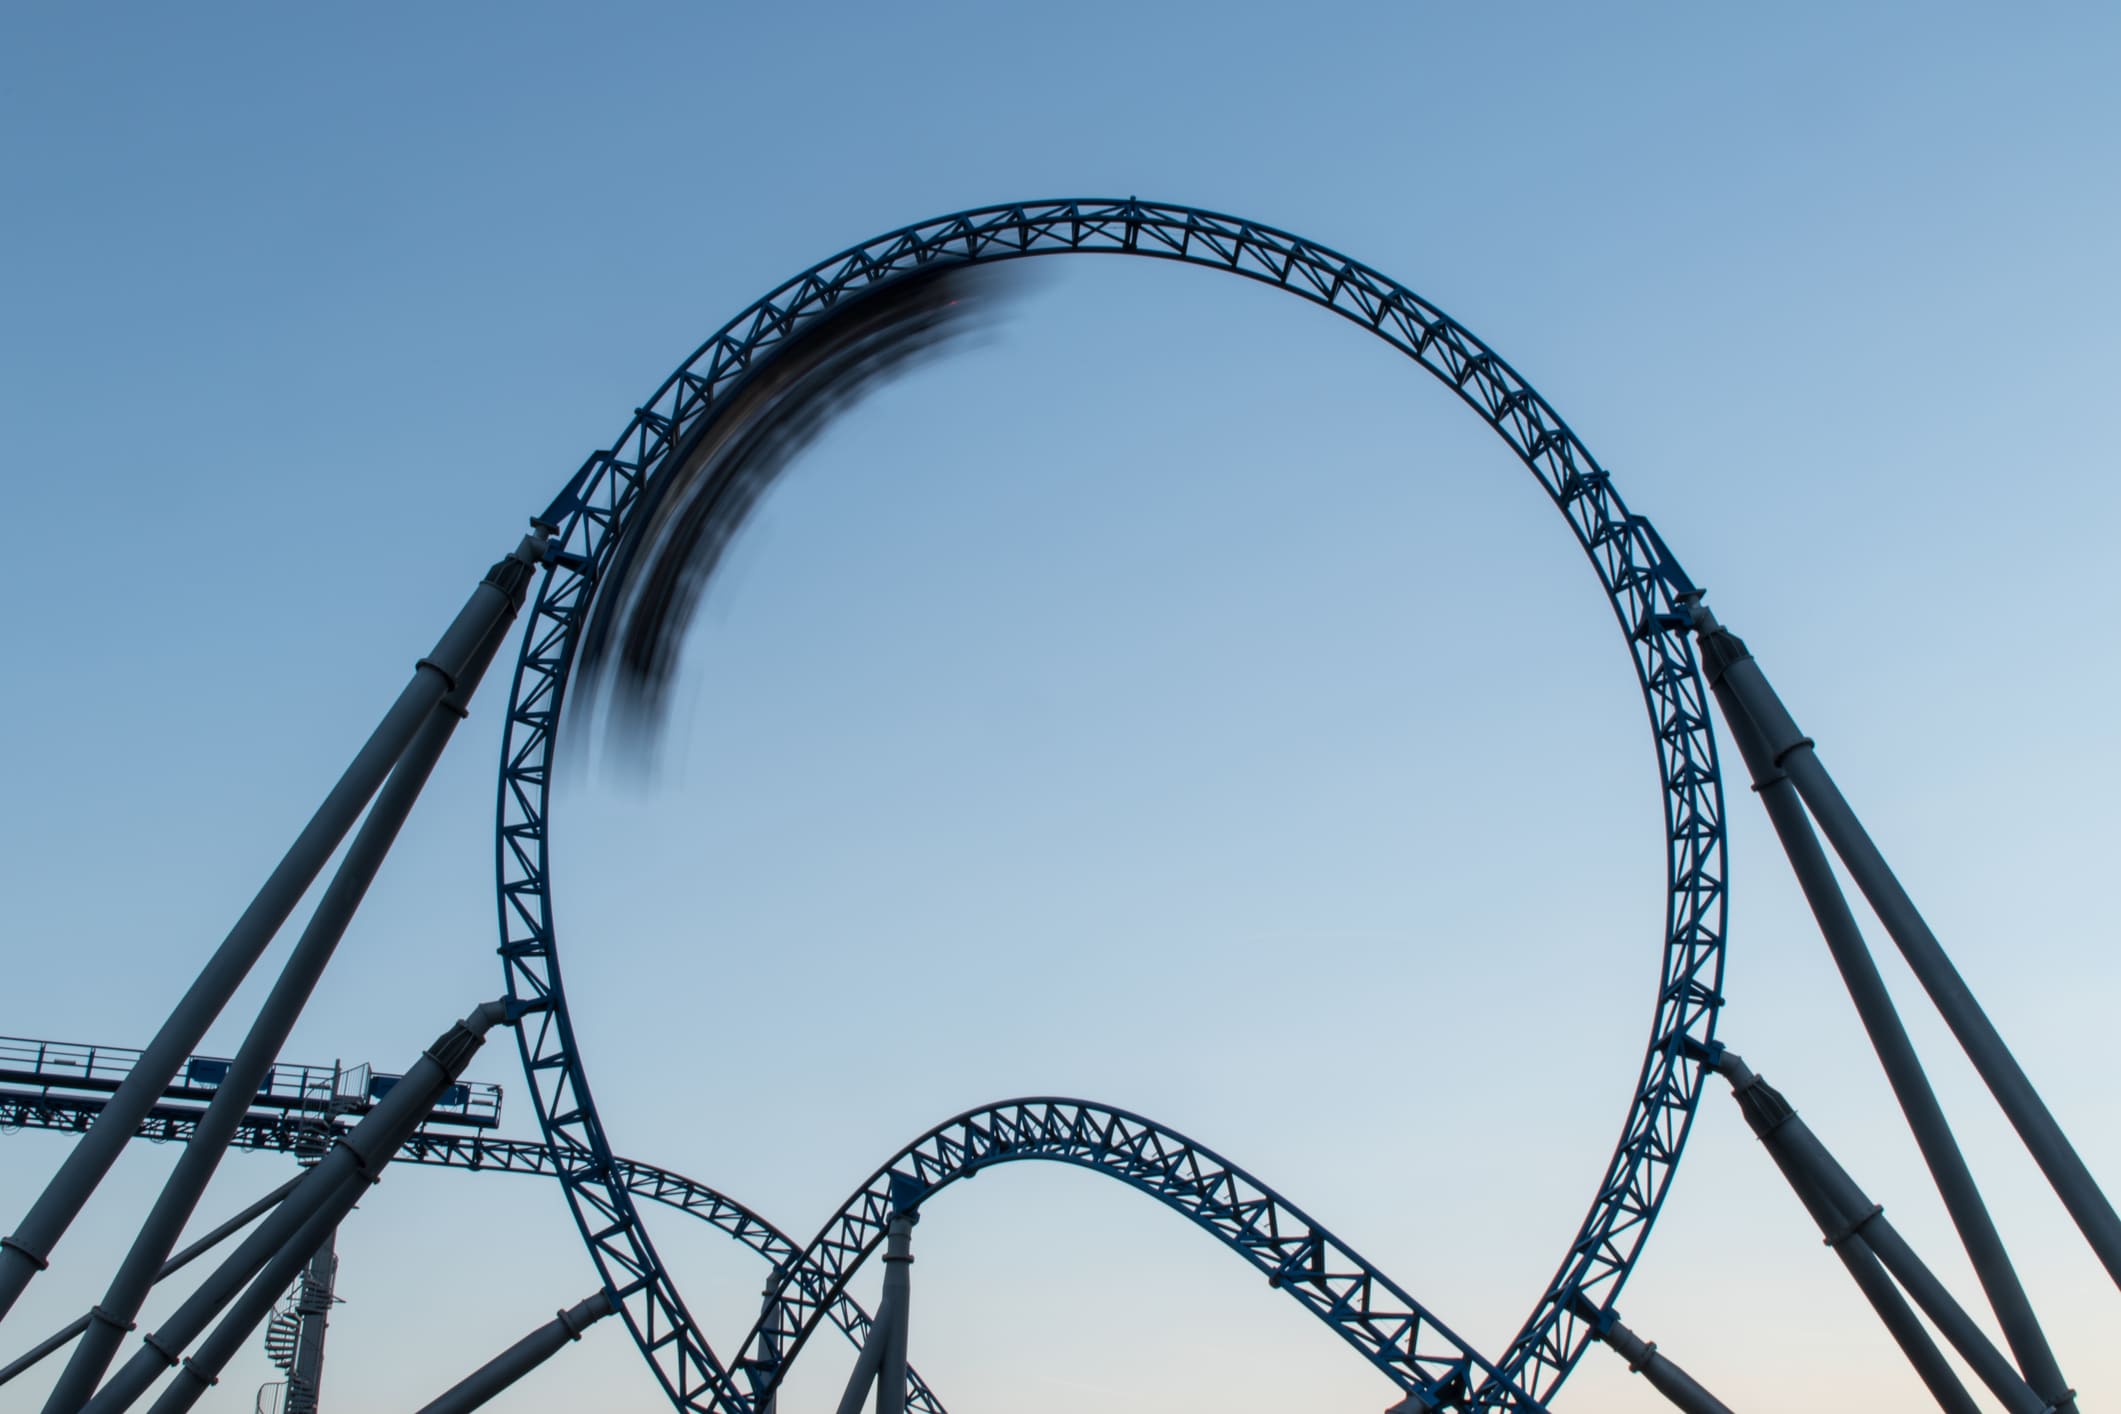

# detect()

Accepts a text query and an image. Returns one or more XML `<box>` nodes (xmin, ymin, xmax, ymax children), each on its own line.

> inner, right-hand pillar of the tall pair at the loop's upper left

<box><xmin>45</xmin><ymin>560</ymin><xmax>530</xmax><ymax>1414</ymax></box>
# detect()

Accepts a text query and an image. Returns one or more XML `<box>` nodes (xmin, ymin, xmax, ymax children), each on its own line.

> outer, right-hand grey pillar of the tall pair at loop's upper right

<box><xmin>1693</xmin><ymin>604</ymin><xmax>2121</xmax><ymax>1288</ymax></box>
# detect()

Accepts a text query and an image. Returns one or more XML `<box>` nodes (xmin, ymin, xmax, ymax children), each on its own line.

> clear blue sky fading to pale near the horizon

<box><xmin>0</xmin><ymin>4</ymin><xmax>2121</xmax><ymax>1414</ymax></box>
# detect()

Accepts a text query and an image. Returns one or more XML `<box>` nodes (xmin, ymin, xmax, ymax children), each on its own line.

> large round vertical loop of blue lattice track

<box><xmin>496</xmin><ymin>199</ymin><xmax>1724</xmax><ymax>1414</ymax></box>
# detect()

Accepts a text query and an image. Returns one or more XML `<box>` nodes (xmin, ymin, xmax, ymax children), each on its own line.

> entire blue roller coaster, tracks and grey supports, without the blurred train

<box><xmin>0</xmin><ymin>197</ymin><xmax>2121</xmax><ymax>1414</ymax></box>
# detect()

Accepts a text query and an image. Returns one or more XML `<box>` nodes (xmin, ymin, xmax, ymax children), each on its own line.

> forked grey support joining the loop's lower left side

<box><xmin>81</xmin><ymin>1001</ymin><xmax>515</xmax><ymax>1414</ymax></box>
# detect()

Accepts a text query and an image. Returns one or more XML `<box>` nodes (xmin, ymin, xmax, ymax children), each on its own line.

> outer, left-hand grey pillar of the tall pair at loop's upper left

<box><xmin>0</xmin><ymin>526</ymin><xmax>547</xmax><ymax>1319</ymax></box>
